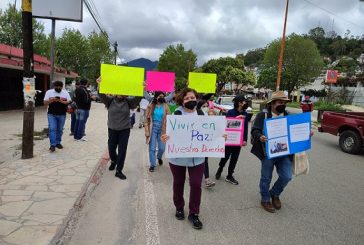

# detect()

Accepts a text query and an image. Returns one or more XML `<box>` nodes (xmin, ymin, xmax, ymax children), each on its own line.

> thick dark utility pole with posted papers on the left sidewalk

<box><xmin>22</xmin><ymin>0</ymin><xmax>35</xmax><ymax>159</ymax></box>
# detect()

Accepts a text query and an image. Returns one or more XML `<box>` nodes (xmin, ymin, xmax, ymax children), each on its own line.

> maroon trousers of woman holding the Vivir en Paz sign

<box><xmin>169</xmin><ymin>163</ymin><xmax>205</xmax><ymax>214</ymax></box>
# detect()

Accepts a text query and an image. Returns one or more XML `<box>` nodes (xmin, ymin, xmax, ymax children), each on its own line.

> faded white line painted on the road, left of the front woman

<box><xmin>143</xmin><ymin>151</ymin><xmax>160</xmax><ymax>245</ymax></box>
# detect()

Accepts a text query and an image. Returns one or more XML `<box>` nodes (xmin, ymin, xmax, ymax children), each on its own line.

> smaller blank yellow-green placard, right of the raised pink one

<box><xmin>188</xmin><ymin>72</ymin><xmax>216</xmax><ymax>93</ymax></box>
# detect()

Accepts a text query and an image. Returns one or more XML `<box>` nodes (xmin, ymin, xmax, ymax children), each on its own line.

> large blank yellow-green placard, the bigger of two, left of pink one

<box><xmin>99</xmin><ymin>64</ymin><xmax>144</xmax><ymax>96</ymax></box>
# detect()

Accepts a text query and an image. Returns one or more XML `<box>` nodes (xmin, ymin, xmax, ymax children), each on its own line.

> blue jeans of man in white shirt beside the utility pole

<box><xmin>48</xmin><ymin>114</ymin><xmax>66</xmax><ymax>146</ymax></box>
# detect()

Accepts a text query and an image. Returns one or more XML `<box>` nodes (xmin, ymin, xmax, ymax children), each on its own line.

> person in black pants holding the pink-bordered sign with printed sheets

<box><xmin>215</xmin><ymin>95</ymin><xmax>250</xmax><ymax>185</ymax></box>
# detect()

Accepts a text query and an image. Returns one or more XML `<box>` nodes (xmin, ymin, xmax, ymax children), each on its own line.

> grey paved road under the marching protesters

<box><xmin>70</xmin><ymin>115</ymin><xmax>364</xmax><ymax>245</ymax></box>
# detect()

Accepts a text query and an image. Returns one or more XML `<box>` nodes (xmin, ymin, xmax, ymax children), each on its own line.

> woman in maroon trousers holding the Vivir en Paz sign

<box><xmin>161</xmin><ymin>88</ymin><xmax>205</xmax><ymax>229</ymax></box>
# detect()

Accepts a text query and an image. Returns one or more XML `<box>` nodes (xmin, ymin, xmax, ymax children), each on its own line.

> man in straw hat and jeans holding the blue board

<box><xmin>251</xmin><ymin>91</ymin><xmax>293</xmax><ymax>213</ymax></box>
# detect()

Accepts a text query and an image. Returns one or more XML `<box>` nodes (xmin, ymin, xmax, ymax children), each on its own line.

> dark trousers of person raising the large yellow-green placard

<box><xmin>108</xmin><ymin>128</ymin><xmax>130</xmax><ymax>172</ymax></box>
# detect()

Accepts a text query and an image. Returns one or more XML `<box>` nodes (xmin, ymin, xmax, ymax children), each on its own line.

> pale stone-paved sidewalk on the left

<box><xmin>0</xmin><ymin>103</ymin><xmax>107</xmax><ymax>245</ymax></box>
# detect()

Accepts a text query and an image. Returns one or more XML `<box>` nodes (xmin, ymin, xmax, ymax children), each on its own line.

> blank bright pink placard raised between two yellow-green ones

<box><xmin>146</xmin><ymin>71</ymin><xmax>175</xmax><ymax>92</ymax></box>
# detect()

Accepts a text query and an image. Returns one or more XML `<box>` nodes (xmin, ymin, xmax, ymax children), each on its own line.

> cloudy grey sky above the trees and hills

<box><xmin>0</xmin><ymin>0</ymin><xmax>364</xmax><ymax>65</ymax></box>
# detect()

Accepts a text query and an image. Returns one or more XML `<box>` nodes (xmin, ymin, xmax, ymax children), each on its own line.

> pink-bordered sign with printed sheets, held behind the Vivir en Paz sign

<box><xmin>225</xmin><ymin>117</ymin><xmax>244</xmax><ymax>146</ymax></box>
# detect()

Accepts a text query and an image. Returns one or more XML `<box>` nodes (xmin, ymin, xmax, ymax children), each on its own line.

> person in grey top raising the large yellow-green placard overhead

<box><xmin>96</xmin><ymin>78</ymin><xmax>136</xmax><ymax>180</ymax></box>
